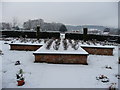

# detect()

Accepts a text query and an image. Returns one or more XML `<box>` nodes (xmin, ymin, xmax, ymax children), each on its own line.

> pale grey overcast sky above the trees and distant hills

<box><xmin>2</xmin><ymin>2</ymin><xmax>118</xmax><ymax>27</ymax></box>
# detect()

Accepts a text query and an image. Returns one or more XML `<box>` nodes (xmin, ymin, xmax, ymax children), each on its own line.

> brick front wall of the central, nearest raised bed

<box><xmin>34</xmin><ymin>54</ymin><xmax>88</xmax><ymax>65</ymax></box>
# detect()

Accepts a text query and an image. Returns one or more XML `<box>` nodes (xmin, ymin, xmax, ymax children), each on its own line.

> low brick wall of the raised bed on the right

<box><xmin>82</xmin><ymin>47</ymin><xmax>114</xmax><ymax>55</ymax></box>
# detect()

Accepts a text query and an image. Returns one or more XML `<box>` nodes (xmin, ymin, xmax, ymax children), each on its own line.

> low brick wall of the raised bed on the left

<box><xmin>10</xmin><ymin>44</ymin><xmax>42</xmax><ymax>51</ymax></box>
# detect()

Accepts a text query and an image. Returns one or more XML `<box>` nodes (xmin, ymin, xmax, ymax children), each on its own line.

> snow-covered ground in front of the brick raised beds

<box><xmin>0</xmin><ymin>41</ymin><xmax>118</xmax><ymax>88</ymax></box>
